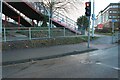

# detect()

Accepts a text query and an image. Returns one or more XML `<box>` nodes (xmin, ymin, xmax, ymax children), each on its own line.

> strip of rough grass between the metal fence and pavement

<box><xmin>2</xmin><ymin>36</ymin><xmax>98</xmax><ymax>51</ymax></box>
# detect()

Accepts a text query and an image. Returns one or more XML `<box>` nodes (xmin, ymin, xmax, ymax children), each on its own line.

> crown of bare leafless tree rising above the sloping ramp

<box><xmin>40</xmin><ymin>0</ymin><xmax>82</xmax><ymax>18</ymax></box>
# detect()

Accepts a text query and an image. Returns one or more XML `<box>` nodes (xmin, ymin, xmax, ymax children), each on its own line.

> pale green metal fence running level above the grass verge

<box><xmin>2</xmin><ymin>27</ymin><xmax>79</xmax><ymax>42</ymax></box>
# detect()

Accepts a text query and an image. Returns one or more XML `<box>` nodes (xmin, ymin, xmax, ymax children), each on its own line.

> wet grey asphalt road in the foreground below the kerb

<box><xmin>3</xmin><ymin>45</ymin><xmax>120</xmax><ymax>78</ymax></box>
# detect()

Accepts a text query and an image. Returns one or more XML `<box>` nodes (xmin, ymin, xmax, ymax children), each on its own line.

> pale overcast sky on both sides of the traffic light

<box><xmin>68</xmin><ymin>0</ymin><xmax>120</xmax><ymax>21</ymax></box>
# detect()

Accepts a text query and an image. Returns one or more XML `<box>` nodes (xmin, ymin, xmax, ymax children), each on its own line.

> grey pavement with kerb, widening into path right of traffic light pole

<box><xmin>2</xmin><ymin>35</ymin><xmax>116</xmax><ymax>65</ymax></box>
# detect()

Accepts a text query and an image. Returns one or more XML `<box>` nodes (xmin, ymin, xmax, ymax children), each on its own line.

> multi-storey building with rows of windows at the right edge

<box><xmin>96</xmin><ymin>3</ymin><xmax>120</xmax><ymax>29</ymax></box>
